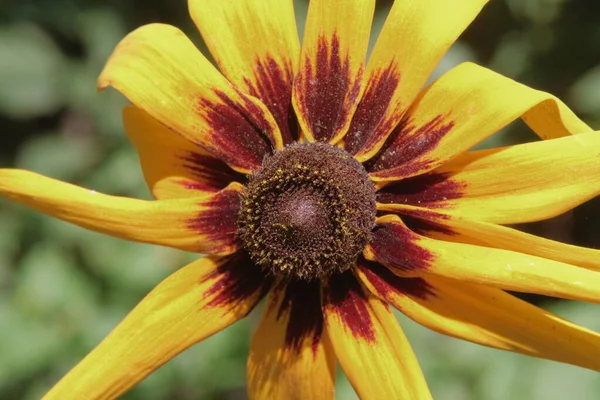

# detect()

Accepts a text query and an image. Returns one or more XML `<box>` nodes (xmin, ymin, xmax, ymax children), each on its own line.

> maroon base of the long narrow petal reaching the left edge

<box><xmin>188</xmin><ymin>185</ymin><xmax>242</xmax><ymax>252</ymax></box>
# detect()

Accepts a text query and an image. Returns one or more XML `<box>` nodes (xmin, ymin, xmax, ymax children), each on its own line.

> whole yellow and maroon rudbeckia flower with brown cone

<box><xmin>0</xmin><ymin>0</ymin><xmax>600</xmax><ymax>400</ymax></box>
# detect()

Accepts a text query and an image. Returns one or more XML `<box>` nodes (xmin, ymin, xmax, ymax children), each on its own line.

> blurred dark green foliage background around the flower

<box><xmin>0</xmin><ymin>0</ymin><xmax>600</xmax><ymax>400</ymax></box>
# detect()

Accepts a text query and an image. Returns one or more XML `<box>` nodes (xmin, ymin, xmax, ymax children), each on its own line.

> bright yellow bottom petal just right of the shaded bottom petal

<box><xmin>323</xmin><ymin>271</ymin><xmax>431</xmax><ymax>400</ymax></box>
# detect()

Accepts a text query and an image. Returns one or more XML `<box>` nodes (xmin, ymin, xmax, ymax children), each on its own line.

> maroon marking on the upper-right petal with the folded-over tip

<box><xmin>365</xmin><ymin>115</ymin><xmax>454</xmax><ymax>177</ymax></box>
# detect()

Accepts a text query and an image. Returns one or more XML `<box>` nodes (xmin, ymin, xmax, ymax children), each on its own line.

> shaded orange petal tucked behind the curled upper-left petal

<box><xmin>123</xmin><ymin>106</ymin><xmax>245</xmax><ymax>200</ymax></box>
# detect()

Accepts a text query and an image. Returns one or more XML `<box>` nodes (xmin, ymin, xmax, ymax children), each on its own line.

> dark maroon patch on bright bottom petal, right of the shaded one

<box><xmin>323</xmin><ymin>270</ymin><xmax>375</xmax><ymax>342</ymax></box>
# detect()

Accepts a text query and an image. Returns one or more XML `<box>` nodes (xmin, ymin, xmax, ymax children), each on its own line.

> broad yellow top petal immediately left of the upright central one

<box><xmin>188</xmin><ymin>0</ymin><xmax>300</xmax><ymax>144</ymax></box>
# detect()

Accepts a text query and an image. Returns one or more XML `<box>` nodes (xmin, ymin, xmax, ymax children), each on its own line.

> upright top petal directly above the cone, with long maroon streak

<box><xmin>292</xmin><ymin>0</ymin><xmax>375</xmax><ymax>143</ymax></box>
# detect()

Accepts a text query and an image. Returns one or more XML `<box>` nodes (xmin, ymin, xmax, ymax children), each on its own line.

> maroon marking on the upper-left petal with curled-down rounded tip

<box><xmin>197</xmin><ymin>90</ymin><xmax>274</xmax><ymax>170</ymax></box>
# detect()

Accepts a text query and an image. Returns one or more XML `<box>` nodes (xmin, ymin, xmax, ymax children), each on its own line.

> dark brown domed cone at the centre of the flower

<box><xmin>238</xmin><ymin>143</ymin><xmax>375</xmax><ymax>280</ymax></box>
